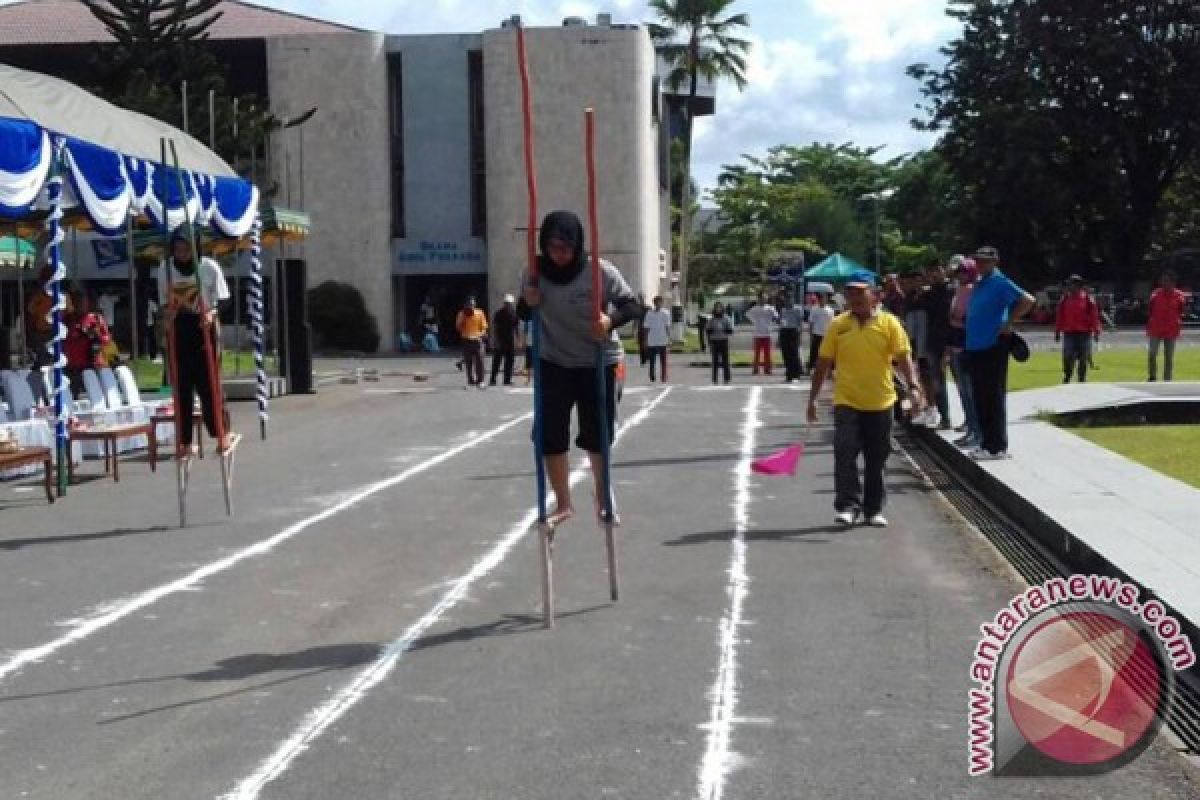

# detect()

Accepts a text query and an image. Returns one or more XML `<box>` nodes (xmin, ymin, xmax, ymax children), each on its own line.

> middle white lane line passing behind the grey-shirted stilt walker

<box><xmin>220</xmin><ymin>389</ymin><xmax>671</xmax><ymax>800</ymax></box>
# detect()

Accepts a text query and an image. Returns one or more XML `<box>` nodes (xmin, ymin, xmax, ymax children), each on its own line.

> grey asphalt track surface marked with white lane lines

<box><xmin>0</xmin><ymin>361</ymin><xmax>1200</xmax><ymax>800</ymax></box>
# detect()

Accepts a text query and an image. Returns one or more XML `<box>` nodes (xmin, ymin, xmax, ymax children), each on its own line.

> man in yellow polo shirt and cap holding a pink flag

<box><xmin>808</xmin><ymin>272</ymin><xmax>924</xmax><ymax>528</ymax></box>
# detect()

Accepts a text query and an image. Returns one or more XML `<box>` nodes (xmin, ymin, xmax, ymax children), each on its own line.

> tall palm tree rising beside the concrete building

<box><xmin>647</xmin><ymin>0</ymin><xmax>750</xmax><ymax>304</ymax></box>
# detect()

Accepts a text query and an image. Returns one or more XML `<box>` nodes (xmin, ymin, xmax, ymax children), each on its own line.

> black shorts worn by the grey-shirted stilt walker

<box><xmin>541</xmin><ymin>361</ymin><xmax>617</xmax><ymax>456</ymax></box>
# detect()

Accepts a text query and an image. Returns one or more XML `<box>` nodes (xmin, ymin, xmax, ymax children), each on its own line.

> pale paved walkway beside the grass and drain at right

<box><xmin>941</xmin><ymin>383</ymin><xmax>1200</xmax><ymax>626</ymax></box>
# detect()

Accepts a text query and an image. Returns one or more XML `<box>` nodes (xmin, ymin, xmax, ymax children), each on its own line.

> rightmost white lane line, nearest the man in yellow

<box><xmin>696</xmin><ymin>386</ymin><xmax>762</xmax><ymax>800</ymax></box>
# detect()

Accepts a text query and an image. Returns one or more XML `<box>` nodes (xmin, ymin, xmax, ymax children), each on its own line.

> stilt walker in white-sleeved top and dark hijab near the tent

<box><xmin>157</xmin><ymin>225</ymin><xmax>236</xmax><ymax>455</ymax></box>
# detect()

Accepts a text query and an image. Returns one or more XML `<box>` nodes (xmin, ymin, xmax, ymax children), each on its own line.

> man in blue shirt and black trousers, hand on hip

<box><xmin>966</xmin><ymin>246</ymin><xmax>1036</xmax><ymax>461</ymax></box>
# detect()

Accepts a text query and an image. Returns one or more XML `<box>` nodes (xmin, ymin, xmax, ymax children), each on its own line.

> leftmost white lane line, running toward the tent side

<box><xmin>0</xmin><ymin>414</ymin><xmax>533</xmax><ymax>681</ymax></box>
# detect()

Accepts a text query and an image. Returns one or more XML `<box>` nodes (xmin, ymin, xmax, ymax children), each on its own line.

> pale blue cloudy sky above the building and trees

<box><xmin>246</xmin><ymin>0</ymin><xmax>958</xmax><ymax>194</ymax></box>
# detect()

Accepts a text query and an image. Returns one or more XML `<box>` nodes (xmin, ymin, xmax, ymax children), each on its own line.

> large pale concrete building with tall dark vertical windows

<box><xmin>0</xmin><ymin>0</ymin><xmax>691</xmax><ymax>350</ymax></box>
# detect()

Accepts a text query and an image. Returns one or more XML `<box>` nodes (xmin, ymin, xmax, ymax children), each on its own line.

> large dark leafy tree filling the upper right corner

<box><xmin>910</xmin><ymin>0</ymin><xmax>1200</xmax><ymax>283</ymax></box>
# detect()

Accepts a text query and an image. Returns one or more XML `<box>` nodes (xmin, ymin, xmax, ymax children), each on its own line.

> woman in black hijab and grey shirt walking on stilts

<box><xmin>518</xmin><ymin>211</ymin><xmax>642</xmax><ymax>527</ymax></box>
